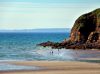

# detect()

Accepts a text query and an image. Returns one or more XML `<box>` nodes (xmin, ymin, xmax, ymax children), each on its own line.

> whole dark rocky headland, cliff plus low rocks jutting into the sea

<box><xmin>39</xmin><ymin>8</ymin><xmax>100</xmax><ymax>49</ymax></box>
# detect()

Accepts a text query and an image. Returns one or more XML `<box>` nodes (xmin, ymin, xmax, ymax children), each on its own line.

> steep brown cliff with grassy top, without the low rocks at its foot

<box><xmin>70</xmin><ymin>8</ymin><xmax>100</xmax><ymax>43</ymax></box>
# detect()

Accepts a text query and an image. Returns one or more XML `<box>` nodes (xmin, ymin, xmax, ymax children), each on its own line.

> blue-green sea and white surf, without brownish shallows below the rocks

<box><xmin>0</xmin><ymin>33</ymin><xmax>72</xmax><ymax>60</ymax></box>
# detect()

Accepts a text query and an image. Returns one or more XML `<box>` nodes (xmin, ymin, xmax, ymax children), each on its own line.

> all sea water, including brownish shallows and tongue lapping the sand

<box><xmin>0</xmin><ymin>32</ymin><xmax>100</xmax><ymax>71</ymax></box>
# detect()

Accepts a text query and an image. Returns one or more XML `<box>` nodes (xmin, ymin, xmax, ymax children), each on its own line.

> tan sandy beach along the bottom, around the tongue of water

<box><xmin>0</xmin><ymin>61</ymin><xmax>100</xmax><ymax>74</ymax></box>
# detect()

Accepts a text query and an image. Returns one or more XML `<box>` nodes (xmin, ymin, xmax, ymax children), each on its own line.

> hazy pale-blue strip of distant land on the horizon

<box><xmin>0</xmin><ymin>28</ymin><xmax>71</xmax><ymax>33</ymax></box>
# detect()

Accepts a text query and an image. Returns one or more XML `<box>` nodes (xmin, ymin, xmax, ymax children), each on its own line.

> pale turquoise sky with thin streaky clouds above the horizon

<box><xmin>0</xmin><ymin>0</ymin><xmax>100</xmax><ymax>30</ymax></box>
